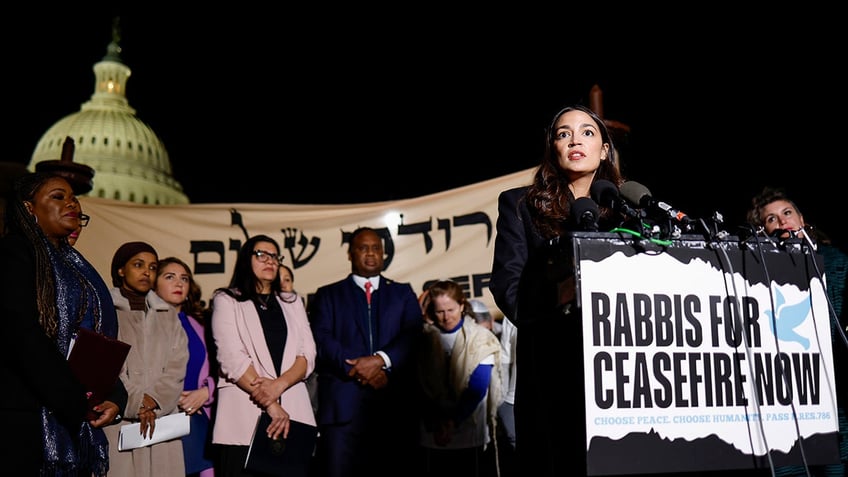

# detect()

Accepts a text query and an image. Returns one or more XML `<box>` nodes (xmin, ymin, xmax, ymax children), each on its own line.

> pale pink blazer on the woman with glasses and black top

<box><xmin>212</xmin><ymin>293</ymin><xmax>316</xmax><ymax>445</ymax></box>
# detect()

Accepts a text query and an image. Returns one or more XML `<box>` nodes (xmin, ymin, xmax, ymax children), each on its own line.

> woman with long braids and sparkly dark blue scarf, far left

<box><xmin>0</xmin><ymin>173</ymin><xmax>127</xmax><ymax>477</ymax></box>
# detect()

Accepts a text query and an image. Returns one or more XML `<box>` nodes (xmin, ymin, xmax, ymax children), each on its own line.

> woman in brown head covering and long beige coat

<box><xmin>102</xmin><ymin>242</ymin><xmax>188</xmax><ymax>477</ymax></box>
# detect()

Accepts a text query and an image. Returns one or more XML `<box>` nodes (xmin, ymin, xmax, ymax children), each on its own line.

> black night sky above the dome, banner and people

<box><xmin>8</xmin><ymin>4</ymin><xmax>848</xmax><ymax>243</ymax></box>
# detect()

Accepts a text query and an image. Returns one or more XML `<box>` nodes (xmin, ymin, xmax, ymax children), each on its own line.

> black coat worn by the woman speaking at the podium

<box><xmin>489</xmin><ymin>187</ymin><xmax>586</xmax><ymax>476</ymax></box>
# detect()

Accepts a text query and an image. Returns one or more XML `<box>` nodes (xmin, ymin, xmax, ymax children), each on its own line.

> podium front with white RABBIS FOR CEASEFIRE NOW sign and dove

<box><xmin>569</xmin><ymin>232</ymin><xmax>839</xmax><ymax>475</ymax></box>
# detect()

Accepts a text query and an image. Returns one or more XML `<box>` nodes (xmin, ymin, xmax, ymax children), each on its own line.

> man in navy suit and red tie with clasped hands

<box><xmin>310</xmin><ymin>227</ymin><xmax>423</xmax><ymax>477</ymax></box>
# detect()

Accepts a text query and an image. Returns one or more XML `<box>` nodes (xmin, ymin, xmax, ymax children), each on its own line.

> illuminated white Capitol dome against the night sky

<box><xmin>27</xmin><ymin>27</ymin><xmax>189</xmax><ymax>205</ymax></box>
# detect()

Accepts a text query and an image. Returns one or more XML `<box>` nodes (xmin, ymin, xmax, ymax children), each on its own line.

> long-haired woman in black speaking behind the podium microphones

<box><xmin>489</xmin><ymin>105</ymin><xmax>624</xmax><ymax>476</ymax></box>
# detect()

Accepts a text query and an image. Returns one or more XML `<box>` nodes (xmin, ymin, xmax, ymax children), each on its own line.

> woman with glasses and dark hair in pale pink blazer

<box><xmin>212</xmin><ymin>235</ymin><xmax>316</xmax><ymax>477</ymax></box>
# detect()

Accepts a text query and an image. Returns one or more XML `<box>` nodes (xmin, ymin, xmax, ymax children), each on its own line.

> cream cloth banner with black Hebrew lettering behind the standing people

<box><xmin>76</xmin><ymin>170</ymin><xmax>533</xmax><ymax>317</ymax></box>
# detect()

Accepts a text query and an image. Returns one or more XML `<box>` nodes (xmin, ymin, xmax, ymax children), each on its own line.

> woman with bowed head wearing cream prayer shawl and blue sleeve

<box><xmin>418</xmin><ymin>280</ymin><xmax>503</xmax><ymax>477</ymax></box>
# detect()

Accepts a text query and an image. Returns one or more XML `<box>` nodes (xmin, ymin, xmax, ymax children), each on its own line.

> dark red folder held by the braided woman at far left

<box><xmin>68</xmin><ymin>328</ymin><xmax>131</xmax><ymax>420</ymax></box>
